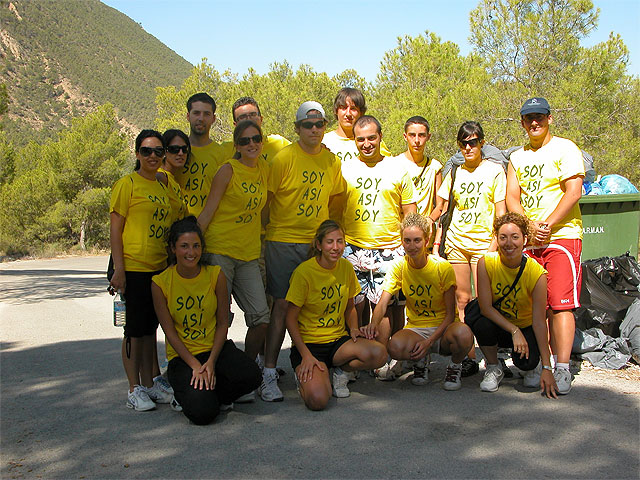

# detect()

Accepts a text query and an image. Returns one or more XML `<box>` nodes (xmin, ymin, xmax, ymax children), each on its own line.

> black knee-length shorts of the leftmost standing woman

<box><xmin>124</xmin><ymin>270</ymin><xmax>162</xmax><ymax>338</ymax></box>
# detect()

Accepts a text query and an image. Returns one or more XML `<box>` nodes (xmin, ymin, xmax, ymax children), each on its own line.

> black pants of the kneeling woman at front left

<box><xmin>167</xmin><ymin>340</ymin><xmax>262</xmax><ymax>425</ymax></box>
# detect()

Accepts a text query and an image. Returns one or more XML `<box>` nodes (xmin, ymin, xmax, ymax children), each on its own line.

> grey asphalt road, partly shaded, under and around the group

<box><xmin>0</xmin><ymin>256</ymin><xmax>640</xmax><ymax>479</ymax></box>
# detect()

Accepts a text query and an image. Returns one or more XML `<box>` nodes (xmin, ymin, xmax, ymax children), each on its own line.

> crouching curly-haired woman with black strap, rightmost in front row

<box><xmin>470</xmin><ymin>212</ymin><xmax>558</xmax><ymax>398</ymax></box>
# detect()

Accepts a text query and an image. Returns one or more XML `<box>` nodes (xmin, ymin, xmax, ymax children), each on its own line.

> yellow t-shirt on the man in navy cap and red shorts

<box><xmin>511</xmin><ymin>136</ymin><xmax>584</xmax><ymax>240</ymax></box>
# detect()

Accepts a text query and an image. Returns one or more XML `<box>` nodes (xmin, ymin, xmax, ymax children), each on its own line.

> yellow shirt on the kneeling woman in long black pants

<box><xmin>152</xmin><ymin>265</ymin><xmax>220</xmax><ymax>360</ymax></box>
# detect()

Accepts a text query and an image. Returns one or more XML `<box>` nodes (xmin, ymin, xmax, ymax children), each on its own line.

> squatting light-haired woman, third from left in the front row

<box><xmin>363</xmin><ymin>213</ymin><xmax>473</xmax><ymax>390</ymax></box>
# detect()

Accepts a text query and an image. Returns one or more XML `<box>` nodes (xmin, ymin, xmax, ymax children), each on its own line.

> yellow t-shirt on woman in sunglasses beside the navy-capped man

<box><xmin>438</xmin><ymin>160</ymin><xmax>507</xmax><ymax>251</ymax></box>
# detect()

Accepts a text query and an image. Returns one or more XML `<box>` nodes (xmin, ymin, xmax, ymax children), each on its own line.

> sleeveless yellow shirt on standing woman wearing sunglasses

<box><xmin>204</xmin><ymin>159</ymin><xmax>268</xmax><ymax>262</ymax></box>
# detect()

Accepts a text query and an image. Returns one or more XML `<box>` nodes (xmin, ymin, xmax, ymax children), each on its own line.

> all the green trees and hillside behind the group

<box><xmin>0</xmin><ymin>0</ymin><xmax>640</xmax><ymax>255</ymax></box>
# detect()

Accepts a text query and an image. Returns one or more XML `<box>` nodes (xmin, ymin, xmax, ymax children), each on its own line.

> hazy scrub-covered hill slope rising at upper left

<box><xmin>0</xmin><ymin>0</ymin><xmax>191</xmax><ymax>145</ymax></box>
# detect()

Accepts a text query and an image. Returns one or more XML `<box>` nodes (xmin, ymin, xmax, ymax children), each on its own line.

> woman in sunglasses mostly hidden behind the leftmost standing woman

<box><xmin>156</xmin><ymin>129</ymin><xmax>191</xmax><ymax>221</ymax></box>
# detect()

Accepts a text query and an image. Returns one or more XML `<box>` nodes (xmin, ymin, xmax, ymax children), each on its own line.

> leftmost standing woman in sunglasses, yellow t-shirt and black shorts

<box><xmin>110</xmin><ymin>130</ymin><xmax>174</xmax><ymax>411</ymax></box>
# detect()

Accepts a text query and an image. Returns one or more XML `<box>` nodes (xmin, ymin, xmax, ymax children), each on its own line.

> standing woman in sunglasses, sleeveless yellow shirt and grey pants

<box><xmin>198</xmin><ymin>120</ymin><xmax>269</xmax><ymax>394</ymax></box>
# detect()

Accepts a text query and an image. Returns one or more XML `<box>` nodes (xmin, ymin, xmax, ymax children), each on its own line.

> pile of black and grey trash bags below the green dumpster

<box><xmin>572</xmin><ymin>252</ymin><xmax>640</xmax><ymax>369</ymax></box>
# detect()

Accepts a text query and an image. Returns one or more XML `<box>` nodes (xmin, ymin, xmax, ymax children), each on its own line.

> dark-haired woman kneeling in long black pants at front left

<box><xmin>151</xmin><ymin>216</ymin><xmax>261</xmax><ymax>425</ymax></box>
